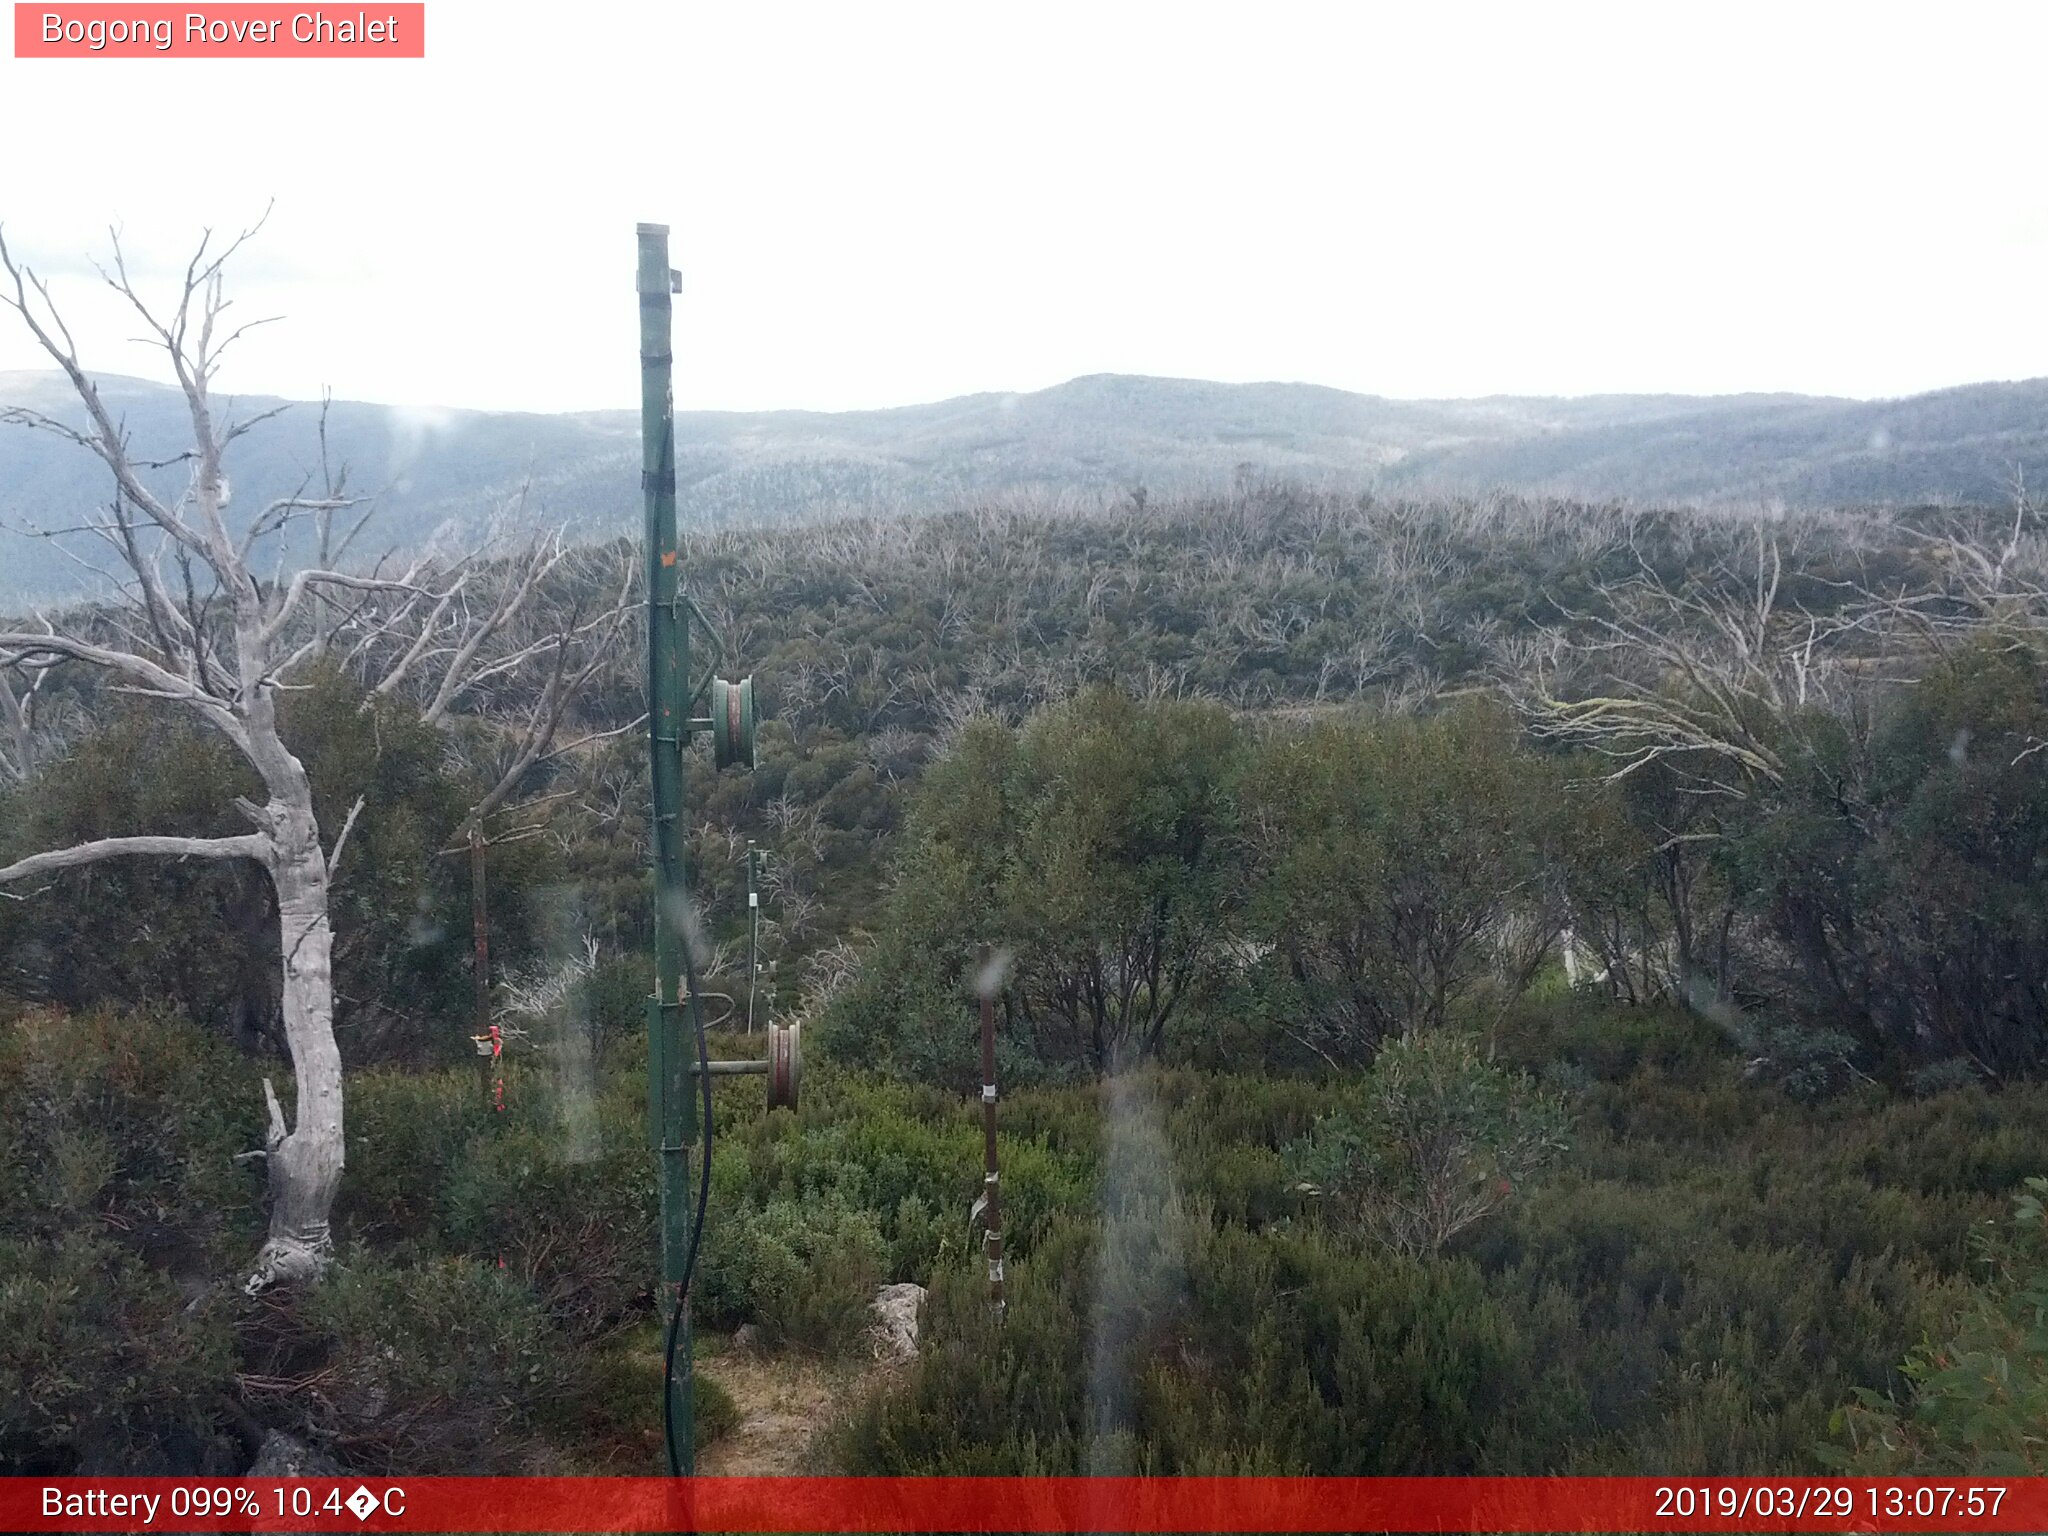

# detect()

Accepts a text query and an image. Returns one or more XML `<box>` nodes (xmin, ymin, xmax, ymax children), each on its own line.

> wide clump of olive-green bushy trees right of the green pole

<box><xmin>839</xmin><ymin>690</ymin><xmax>1614</xmax><ymax>1085</ymax></box>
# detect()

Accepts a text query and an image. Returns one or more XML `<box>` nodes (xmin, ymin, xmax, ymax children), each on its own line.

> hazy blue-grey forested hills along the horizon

<box><xmin>0</xmin><ymin>373</ymin><xmax>2048</xmax><ymax>602</ymax></box>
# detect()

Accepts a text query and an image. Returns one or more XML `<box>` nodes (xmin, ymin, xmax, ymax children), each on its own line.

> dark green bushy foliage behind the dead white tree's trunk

<box><xmin>0</xmin><ymin>672</ymin><xmax>557</xmax><ymax>1065</ymax></box>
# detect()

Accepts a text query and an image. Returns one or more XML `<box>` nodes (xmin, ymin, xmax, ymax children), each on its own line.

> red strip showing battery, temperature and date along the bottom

<box><xmin>0</xmin><ymin>1477</ymin><xmax>2048</xmax><ymax>1532</ymax></box>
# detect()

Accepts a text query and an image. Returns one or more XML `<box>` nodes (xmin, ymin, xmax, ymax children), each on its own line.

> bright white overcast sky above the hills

<box><xmin>0</xmin><ymin>0</ymin><xmax>2048</xmax><ymax>410</ymax></box>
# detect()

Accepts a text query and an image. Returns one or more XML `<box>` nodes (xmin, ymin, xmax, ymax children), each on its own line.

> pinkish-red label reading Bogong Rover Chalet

<box><xmin>14</xmin><ymin>0</ymin><xmax>426</xmax><ymax>59</ymax></box>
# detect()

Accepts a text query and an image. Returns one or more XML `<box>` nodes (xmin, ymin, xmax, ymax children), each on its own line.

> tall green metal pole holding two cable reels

<box><xmin>635</xmin><ymin>223</ymin><xmax>696</xmax><ymax>1473</ymax></box>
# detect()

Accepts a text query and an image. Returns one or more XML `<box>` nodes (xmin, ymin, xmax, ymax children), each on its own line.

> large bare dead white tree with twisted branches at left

<box><xmin>0</xmin><ymin>225</ymin><xmax>614</xmax><ymax>1294</ymax></box>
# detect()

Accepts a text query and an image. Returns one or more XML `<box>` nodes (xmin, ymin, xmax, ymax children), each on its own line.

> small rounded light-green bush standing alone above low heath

<box><xmin>1286</xmin><ymin>1030</ymin><xmax>1569</xmax><ymax>1255</ymax></box>
